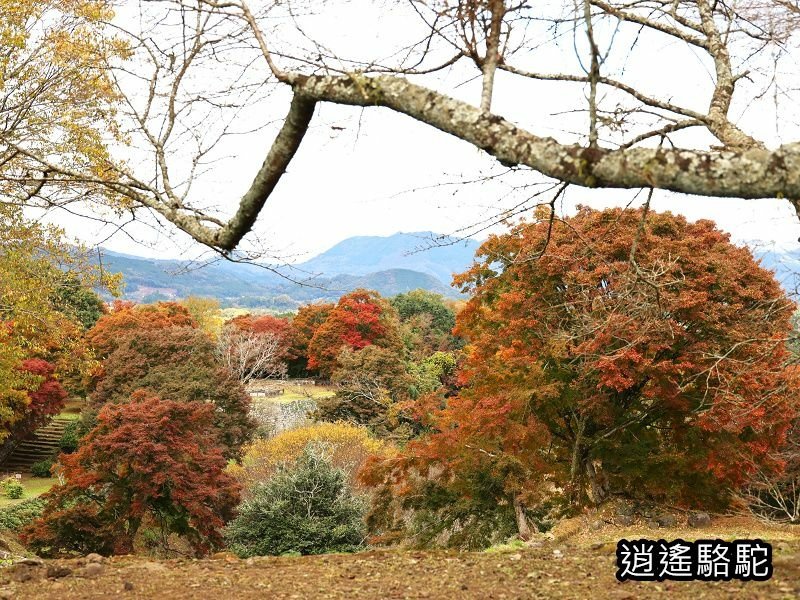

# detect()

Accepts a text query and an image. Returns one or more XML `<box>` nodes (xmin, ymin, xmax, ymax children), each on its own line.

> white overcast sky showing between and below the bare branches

<box><xmin>39</xmin><ymin>0</ymin><xmax>800</xmax><ymax>262</ymax></box>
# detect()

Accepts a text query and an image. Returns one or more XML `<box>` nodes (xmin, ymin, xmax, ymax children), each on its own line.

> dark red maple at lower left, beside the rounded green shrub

<box><xmin>22</xmin><ymin>392</ymin><xmax>239</xmax><ymax>555</ymax></box>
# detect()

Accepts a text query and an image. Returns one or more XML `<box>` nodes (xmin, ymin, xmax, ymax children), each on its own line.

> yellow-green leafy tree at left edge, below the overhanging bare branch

<box><xmin>0</xmin><ymin>203</ymin><xmax>119</xmax><ymax>444</ymax></box>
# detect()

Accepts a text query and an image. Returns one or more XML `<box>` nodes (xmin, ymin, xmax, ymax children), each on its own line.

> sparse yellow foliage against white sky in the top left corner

<box><xmin>0</xmin><ymin>0</ymin><xmax>128</xmax><ymax>208</ymax></box>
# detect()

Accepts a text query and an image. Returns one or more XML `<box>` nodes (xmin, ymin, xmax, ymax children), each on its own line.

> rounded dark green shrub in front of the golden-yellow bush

<box><xmin>225</xmin><ymin>447</ymin><xmax>366</xmax><ymax>558</ymax></box>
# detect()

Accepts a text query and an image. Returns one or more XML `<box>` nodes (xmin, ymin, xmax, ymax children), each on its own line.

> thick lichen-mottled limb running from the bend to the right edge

<box><xmin>289</xmin><ymin>74</ymin><xmax>800</xmax><ymax>198</ymax></box>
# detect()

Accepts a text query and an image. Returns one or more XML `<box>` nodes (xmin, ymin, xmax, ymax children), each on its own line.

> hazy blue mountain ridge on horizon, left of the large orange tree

<box><xmin>97</xmin><ymin>232</ymin><xmax>479</xmax><ymax>310</ymax></box>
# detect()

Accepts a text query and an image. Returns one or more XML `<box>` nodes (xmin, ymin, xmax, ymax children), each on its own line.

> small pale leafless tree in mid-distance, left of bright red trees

<box><xmin>217</xmin><ymin>325</ymin><xmax>286</xmax><ymax>385</ymax></box>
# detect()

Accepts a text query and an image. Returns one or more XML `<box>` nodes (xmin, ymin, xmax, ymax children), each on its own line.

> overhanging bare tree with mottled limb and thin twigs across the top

<box><xmin>6</xmin><ymin>0</ymin><xmax>800</xmax><ymax>253</ymax></box>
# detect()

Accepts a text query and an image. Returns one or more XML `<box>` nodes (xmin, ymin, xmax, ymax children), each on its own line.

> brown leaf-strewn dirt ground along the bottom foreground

<box><xmin>0</xmin><ymin>522</ymin><xmax>800</xmax><ymax>600</ymax></box>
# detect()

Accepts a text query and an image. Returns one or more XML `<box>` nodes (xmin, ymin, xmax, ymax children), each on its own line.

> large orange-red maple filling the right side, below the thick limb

<box><xmin>368</xmin><ymin>208</ymin><xmax>798</xmax><ymax>544</ymax></box>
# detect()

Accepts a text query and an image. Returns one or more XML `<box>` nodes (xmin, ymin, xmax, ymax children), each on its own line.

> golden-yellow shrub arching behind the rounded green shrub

<box><xmin>228</xmin><ymin>423</ymin><xmax>390</xmax><ymax>490</ymax></box>
